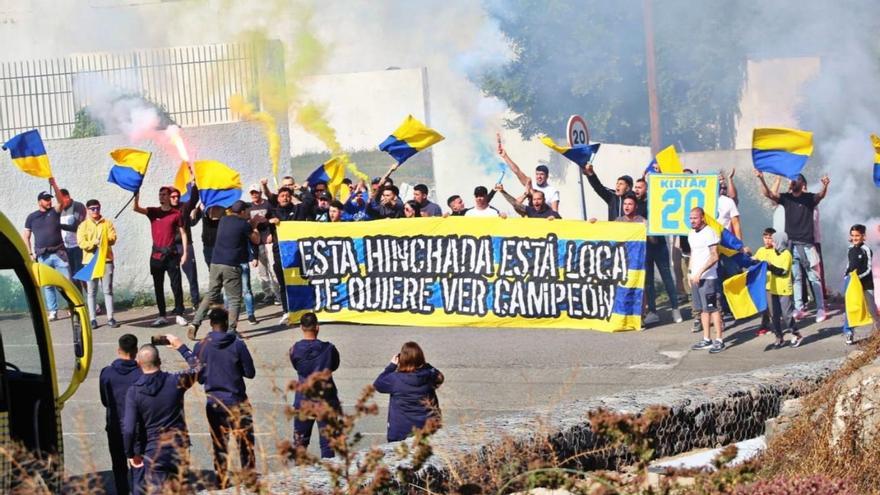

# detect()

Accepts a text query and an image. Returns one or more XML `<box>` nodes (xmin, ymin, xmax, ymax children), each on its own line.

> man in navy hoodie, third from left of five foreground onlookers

<box><xmin>193</xmin><ymin>308</ymin><xmax>257</xmax><ymax>488</ymax></box>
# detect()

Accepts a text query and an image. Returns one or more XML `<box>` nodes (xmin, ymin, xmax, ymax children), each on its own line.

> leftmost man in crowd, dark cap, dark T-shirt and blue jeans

<box><xmin>22</xmin><ymin>177</ymin><xmax>76</xmax><ymax>321</ymax></box>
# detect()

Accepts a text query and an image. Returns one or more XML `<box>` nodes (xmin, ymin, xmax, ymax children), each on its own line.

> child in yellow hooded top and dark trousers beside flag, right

<box><xmin>754</xmin><ymin>228</ymin><xmax>803</xmax><ymax>349</ymax></box>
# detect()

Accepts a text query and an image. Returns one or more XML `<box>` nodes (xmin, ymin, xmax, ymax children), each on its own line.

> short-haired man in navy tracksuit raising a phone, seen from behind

<box><xmin>122</xmin><ymin>334</ymin><xmax>201</xmax><ymax>493</ymax></box>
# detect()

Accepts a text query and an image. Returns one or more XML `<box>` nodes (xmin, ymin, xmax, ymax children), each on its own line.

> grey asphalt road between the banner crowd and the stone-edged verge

<box><xmin>46</xmin><ymin>300</ymin><xmax>851</xmax><ymax>494</ymax></box>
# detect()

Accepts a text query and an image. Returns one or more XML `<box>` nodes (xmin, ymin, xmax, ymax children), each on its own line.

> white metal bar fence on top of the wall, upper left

<box><xmin>0</xmin><ymin>44</ymin><xmax>259</xmax><ymax>139</ymax></box>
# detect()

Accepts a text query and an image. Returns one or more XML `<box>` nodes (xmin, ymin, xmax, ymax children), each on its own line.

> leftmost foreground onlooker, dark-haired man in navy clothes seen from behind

<box><xmin>98</xmin><ymin>333</ymin><xmax>143</xmax><ymax>495</ymax></box>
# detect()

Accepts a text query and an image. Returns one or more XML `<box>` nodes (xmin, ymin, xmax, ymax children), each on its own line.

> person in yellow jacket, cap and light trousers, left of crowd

<box><xmin>76</xmin><ymin>199</ymin><xmax>119</xmax><ymax>329</ymax></box>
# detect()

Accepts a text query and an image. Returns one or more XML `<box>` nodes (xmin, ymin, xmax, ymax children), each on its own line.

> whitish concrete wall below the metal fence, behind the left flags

<box><xmin>0</xmin><ymin>123</ymin><xmax>287</xmax><ymax>297</ymax></box>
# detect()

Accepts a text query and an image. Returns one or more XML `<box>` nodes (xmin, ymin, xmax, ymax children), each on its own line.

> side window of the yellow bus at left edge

<box><xmin>0</xmin><ymin>267</ymin><xmax>43</xmax><ymax>375</ymax></box>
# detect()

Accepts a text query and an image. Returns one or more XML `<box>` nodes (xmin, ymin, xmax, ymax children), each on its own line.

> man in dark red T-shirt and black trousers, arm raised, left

<box><xmin>132</xmin><ymin>186</ymin><xmax>187</xmax><ymax>327</ymax></box>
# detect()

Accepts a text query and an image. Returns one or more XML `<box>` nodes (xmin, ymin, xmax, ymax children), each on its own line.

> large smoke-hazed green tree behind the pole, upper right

<box><xmin>478</xmin><ymin>0</ymin><xmax>748</xmax><ymax>150</ymax></box>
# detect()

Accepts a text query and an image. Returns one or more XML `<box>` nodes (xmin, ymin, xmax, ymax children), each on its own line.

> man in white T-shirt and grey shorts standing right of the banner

<box><xmin>688</xmin><ymin>207</ymin><xmax>724</xmax><ymax>354</ymax></box>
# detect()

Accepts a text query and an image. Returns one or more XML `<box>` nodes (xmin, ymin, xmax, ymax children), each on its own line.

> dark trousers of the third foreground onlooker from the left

<box><xmin>205</xmin><ymin>400</ymin><xmax>256</xmax><ymax>487</ymax></box>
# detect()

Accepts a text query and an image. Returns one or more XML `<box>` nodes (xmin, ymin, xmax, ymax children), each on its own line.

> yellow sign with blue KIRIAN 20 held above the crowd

<box><xmin>647</xmin><ymin>174</ymin><xmax>718</xmax><ymax>235</ymax></box>
